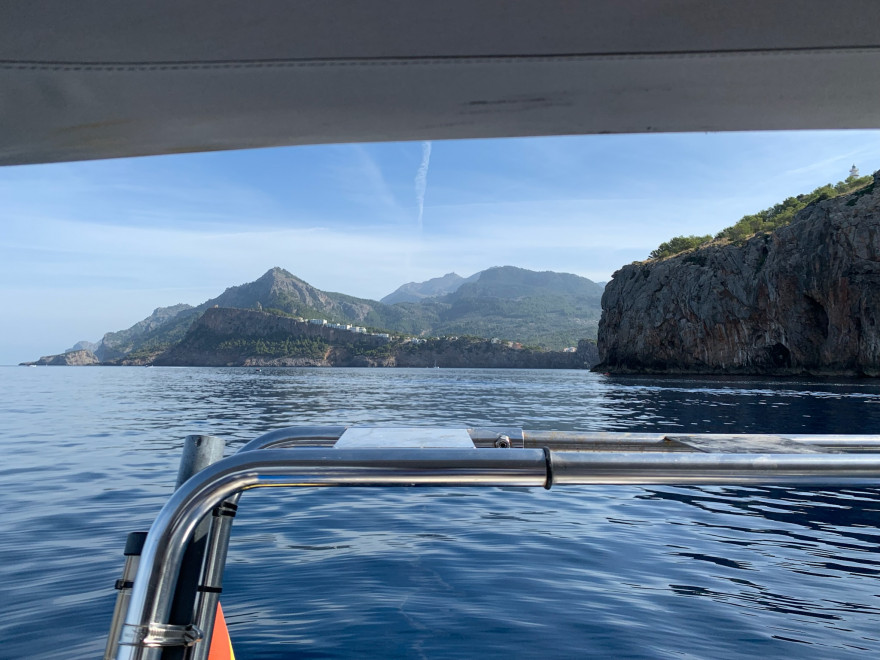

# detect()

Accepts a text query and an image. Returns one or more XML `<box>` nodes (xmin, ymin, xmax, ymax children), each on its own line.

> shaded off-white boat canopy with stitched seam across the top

<box><xmin>0</xmin><ymin>0</ymin><xmax>880</xmax><ymax>165</ymax></box>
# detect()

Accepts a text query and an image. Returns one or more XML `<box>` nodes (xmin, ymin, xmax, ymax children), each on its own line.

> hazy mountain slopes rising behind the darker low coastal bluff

<box><xmin>36</xmin><ymin>266</ymin><xmax>602</xmax><ymax>362</ymax></box>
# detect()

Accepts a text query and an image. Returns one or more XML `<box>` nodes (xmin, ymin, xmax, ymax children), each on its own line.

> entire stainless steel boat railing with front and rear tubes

<box><xmin>116</xmin><ymin>427</ymin><xmax>880</xmax><ymax>660</ymax></box>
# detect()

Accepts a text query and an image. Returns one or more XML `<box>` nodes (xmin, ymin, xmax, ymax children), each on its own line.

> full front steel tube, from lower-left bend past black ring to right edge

<box><xmin>117</xmin><ymin>446</ymin><xmax>880</xmax><ymax>660</ymax></box>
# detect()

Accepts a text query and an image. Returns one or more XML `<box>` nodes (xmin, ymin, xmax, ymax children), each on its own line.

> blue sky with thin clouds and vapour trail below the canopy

<box><xmin>0</xmin><ymin>131</ymin><xmax>880</xmax><ymax>364</ymax></box>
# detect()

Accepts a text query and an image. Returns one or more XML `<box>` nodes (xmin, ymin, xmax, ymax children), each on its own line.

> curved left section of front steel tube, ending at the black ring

<box><xmin>117</xmin><ymin>448</ymin><xmax>547</xmax><ymax>660</ymax></box>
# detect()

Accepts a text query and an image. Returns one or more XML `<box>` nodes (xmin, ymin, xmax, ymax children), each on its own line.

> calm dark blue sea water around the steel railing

<box><xmin>0</xmin><ymin>367</ymin><xmax>880</xmax><ymax>659</ymax></box>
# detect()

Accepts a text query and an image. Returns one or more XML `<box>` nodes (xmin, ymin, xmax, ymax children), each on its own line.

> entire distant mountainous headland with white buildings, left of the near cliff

<box><xmin>23</xmin><ymin>266</ymin><xmax>603</xmax><ymax>369</ymax></box>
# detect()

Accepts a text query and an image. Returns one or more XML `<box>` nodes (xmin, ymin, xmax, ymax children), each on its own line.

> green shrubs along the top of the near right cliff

<box><xmin>649</xmin><ymin>176</ymin><xmax>874</xmax><ymax>259</ymax></box>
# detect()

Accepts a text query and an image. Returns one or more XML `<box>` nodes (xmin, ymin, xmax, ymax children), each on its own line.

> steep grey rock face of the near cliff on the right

<box><xmin>597</xmin><ymin>173</ymin><xmax>880</xmax><ymax>376</ymax></box>
